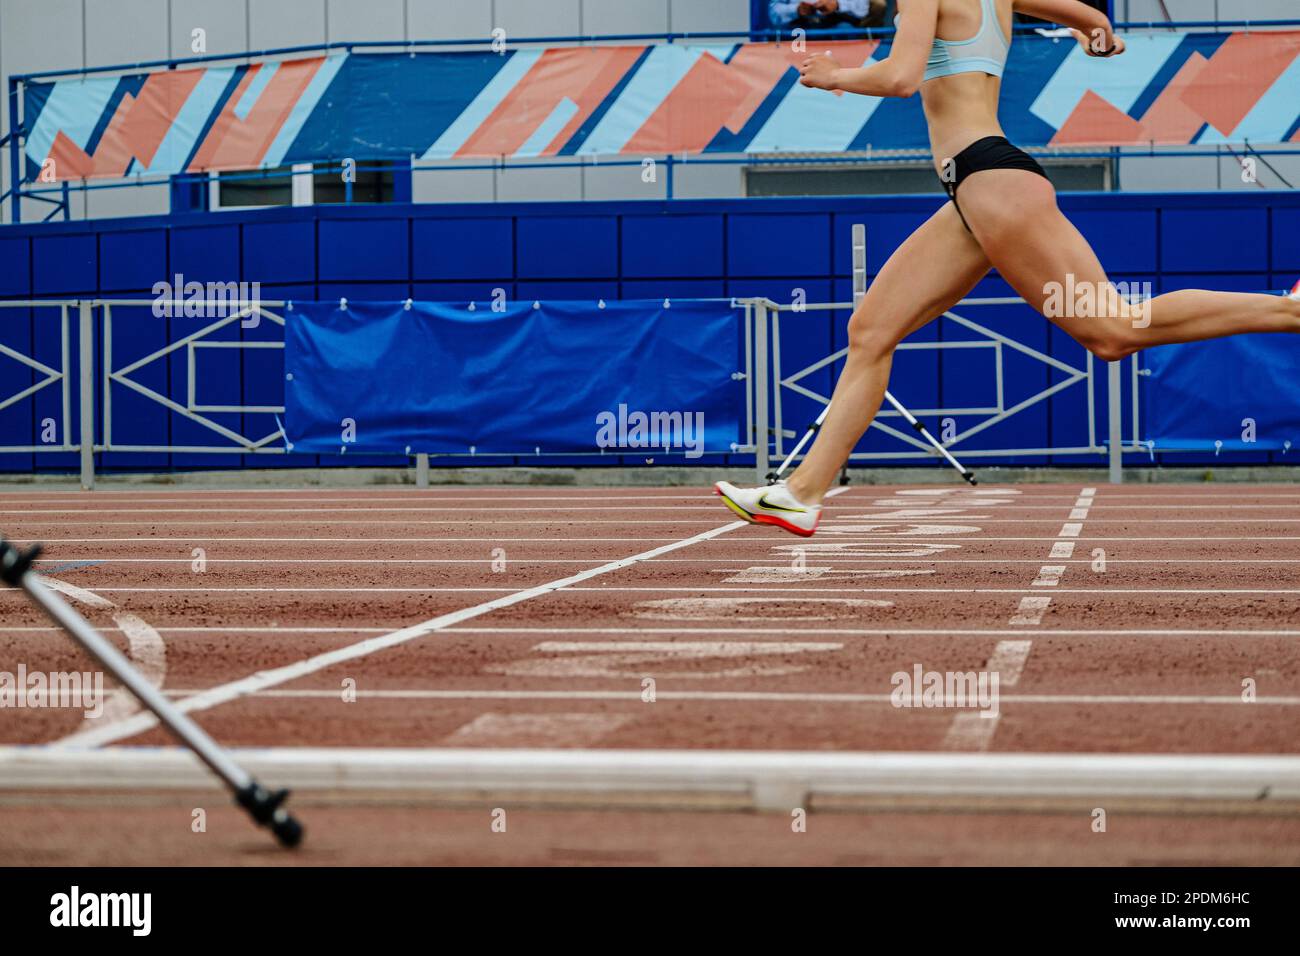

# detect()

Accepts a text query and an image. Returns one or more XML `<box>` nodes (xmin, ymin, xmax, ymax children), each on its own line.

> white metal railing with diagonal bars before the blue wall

<box><xmin>0</xmin><ymin>290</ymin><xmax>1151</xmax><ymax>488</ymax></box>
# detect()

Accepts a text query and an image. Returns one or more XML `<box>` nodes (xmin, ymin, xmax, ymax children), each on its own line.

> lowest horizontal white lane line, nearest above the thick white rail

<box><xmin>152</xmin><ymin>688</ymin><xmax>1300</xmax><ymax>707</ymax></box>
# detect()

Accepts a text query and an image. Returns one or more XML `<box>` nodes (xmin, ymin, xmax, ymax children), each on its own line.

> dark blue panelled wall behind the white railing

<box><xmin>0</xmin><ymin>190</ymin><xmax>1300</xmax><ymax>471</ymax></box>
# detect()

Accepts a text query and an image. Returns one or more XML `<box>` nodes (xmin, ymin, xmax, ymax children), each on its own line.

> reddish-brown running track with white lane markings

<box><xmin>0</xmin><ymin>485</ymin><xmax>1300</xmax><ymax>864</ymax></box>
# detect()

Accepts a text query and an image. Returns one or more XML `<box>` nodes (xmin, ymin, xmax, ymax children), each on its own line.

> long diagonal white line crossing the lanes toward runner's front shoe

<box><xmin>56</xmin><ymin>522</ymin><xmax>745</xmax><ymax>747</ymax></box>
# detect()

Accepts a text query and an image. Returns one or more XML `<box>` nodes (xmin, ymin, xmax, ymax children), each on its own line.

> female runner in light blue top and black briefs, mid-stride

<box><xmin>714</xmin><ymin>0</ymin><xmax>1300</xmax><ymax>537</ymax></box>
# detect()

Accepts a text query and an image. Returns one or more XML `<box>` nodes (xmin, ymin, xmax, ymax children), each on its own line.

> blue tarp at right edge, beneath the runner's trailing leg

<box><xmin>1143</xmin><ymin>336</ymin><xmax>1300</xmax><ymax>454</ymax></box>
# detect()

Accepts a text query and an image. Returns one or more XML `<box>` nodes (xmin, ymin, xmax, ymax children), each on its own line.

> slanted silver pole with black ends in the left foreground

<box><xmin>0</xmin><ymin>538</ymin><xmax>303</xmax><ymax>847</ymax></box>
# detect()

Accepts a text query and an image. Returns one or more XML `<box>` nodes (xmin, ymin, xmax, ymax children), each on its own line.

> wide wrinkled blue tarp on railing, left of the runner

<box><xmin>285</xmin><ymin>300</ymin><xmax>745</xmax><ymax>459</ymax></box>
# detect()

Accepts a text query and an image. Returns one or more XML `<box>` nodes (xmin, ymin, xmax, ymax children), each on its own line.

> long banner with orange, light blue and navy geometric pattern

<box><xmin>23</xmin><ymin>31</ymin><xmax>1300</xmax><ymax>179</ymax></box>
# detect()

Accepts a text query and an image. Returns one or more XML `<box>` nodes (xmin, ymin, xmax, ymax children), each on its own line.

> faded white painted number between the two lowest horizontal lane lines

<box><xmin>486</xmin><ymin>641</ymin><xmax>844</xmax><ymax>680</ymax></box>
